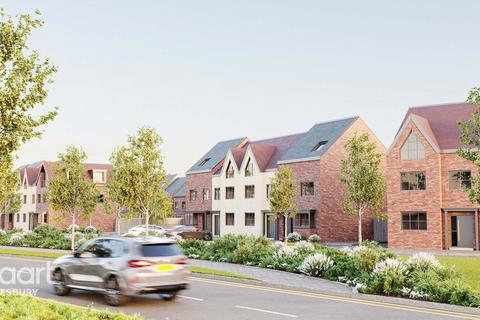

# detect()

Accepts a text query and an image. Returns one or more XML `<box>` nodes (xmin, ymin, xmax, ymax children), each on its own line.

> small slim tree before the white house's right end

<box><xmin>269</xmin><ymin>166</ymin><xmax>298</xmax><ymax>241</ymax></box>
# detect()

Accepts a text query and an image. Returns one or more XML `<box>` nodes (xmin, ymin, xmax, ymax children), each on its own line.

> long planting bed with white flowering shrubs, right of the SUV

<box><xmin>179</xmin><ymin>235</ymin><xmax>480</xmax><ymax>307</ymax></box>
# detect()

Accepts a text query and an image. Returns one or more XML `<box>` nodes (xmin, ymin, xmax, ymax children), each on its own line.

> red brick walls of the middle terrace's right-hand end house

<box><xmin>280</xmin><ymin>118</ymin><xmax>385</xmax><ymax>242</ymax></box>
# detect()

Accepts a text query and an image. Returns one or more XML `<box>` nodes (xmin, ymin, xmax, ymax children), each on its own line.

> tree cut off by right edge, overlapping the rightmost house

<box><xmin>457</xmin><ymin>87</ymin><xmax>480</xmax><ymax>204</ymax></box>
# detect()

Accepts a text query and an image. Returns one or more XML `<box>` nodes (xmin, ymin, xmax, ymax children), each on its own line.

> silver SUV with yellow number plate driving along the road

<box><xmin>51</xmin><ymin>236</ymin><xmax>190</xmax><ymax>306</ymax></box>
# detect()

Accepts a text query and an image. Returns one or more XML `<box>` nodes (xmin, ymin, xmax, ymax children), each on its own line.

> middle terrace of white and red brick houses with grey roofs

<box><xmin>185</xmin><ymin>117</ymin><xmax>385</xmax><ymax>242</ymax></box>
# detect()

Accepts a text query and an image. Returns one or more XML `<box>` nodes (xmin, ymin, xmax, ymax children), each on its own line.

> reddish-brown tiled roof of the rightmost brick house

<box><xmin>397</xmin><ymin>103</ymin><xmax>476</xmax><ymax>150</ymax></box>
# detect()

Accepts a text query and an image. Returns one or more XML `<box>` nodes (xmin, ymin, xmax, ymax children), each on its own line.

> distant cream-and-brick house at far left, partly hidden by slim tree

<box><xmin>0</xmin><ymin>161</ymin><xmax>115</xmax><ymax>232</ymax></box>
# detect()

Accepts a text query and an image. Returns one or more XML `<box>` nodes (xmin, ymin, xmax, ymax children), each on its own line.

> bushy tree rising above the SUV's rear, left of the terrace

<box><xmin>107</xmin><ymin>127</ymin><xmax>172</xmax><ymax>235</ymax></box>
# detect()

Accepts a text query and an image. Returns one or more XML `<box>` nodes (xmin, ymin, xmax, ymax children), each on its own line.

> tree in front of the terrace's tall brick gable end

<box><xmin>340</xmin><ymin>133</ymin><xmax>386</xmax><ymax>243</ymax></box>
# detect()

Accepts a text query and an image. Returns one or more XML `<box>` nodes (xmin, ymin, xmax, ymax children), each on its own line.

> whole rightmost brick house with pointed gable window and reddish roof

<box><xmin>386</xmin><ymin>103</ymin><xmax>479</xmax><ymax>250</ymax></box>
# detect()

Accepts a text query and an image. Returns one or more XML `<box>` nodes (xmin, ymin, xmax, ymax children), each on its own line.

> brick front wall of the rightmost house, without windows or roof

<box><xmin>386</xmin><ymin>121</ymin><xmax>476</xmax><ymax>249</ymax></box>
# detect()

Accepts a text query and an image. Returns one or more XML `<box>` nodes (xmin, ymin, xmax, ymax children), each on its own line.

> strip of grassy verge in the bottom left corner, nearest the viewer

<box><xmin>0</xmin><ymin>294</ymin><xmax>142</xmax><ymax>320</ymax></box>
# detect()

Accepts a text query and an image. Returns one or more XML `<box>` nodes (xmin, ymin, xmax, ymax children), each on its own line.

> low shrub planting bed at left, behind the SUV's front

<box><xmin>0</xmin><ymin>225</ymin><xmax>100</xmax><ymax>250</ymax></box>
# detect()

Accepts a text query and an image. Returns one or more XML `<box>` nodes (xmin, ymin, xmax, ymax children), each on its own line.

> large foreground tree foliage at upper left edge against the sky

<box><xmin>0</xmin><ymin>8</ymin><xmax>57</xmax><ymax>213</ymax></box>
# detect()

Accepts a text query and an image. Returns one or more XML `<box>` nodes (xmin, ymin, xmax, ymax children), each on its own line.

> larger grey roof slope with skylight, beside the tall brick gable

<box><xmin>279</xmin><ymin>117</ymin><xmax>358</xmax><ymax>163</ymax></box>
